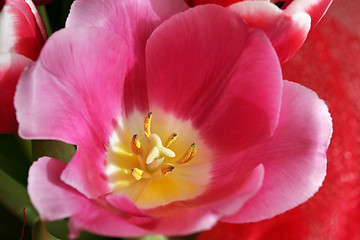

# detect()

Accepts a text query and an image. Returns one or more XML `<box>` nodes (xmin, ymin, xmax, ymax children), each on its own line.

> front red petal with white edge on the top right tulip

<box><xmin>229</xmin><ymin>1</ymin><xmax>311</xmax><ymax>62</ymax></box>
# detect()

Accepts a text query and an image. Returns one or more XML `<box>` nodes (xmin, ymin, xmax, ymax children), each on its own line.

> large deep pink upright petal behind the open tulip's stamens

<box><xmin>146</xmin><ymin>5</ymin><xmax>282</xmax><ymax>154</ymax></box>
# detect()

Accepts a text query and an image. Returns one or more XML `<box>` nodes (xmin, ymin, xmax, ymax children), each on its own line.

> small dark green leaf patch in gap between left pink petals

<box><xmin>32</xmin><ymin>140</ymin><xmax>76</xmax><ymax>162</ymax></box>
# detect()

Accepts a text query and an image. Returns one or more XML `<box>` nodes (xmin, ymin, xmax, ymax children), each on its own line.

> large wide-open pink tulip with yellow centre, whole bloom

<box><xmin>15</xmin><ymin>0</ymin><xmax>332</xmax><ymax>237</ymax></box>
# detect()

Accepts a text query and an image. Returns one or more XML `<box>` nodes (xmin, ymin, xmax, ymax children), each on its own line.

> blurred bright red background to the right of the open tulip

<box><xmin>198</xmin><ymin>0</ymin><xmax>360</xmax><ymax>240</ymax></box>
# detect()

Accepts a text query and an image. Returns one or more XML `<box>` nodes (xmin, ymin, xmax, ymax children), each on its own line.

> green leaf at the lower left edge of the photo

<box><xmin>0</xmin><ymin>169</ymin><xmax>39</xmax><ymax>225</ymax></box>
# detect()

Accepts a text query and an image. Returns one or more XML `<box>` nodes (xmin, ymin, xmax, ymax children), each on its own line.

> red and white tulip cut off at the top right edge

<box><xmin>185</xmin><ymin>0</ymin><xmax>332</xmax><ymax>62</ymax></box>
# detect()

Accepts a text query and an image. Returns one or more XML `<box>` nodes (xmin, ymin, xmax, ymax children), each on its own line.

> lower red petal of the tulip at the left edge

<box><xmin>0</xmin><ymin>53</ymin><xmax>32</xmax><ymax>133</ymax></box>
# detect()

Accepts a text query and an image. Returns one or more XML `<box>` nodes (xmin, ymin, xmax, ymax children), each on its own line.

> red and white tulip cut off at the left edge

<box><xmin>0</xmin><ymin>0</ymin><xmax>47</xmax><ymax>133</ymax></box>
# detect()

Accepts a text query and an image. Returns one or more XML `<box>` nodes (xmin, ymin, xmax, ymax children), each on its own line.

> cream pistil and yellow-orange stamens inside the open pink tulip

<box><xmin>131</xmin><ymin>112</ymin><xmax>196</xmax><ymax>181</ymax></box>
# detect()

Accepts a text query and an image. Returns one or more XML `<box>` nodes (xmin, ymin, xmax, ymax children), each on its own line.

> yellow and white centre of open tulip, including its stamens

<box><xmin>106</xmin><ymin>110</ymin><xmax>211</xmax><ymax>208</ymax></box>
